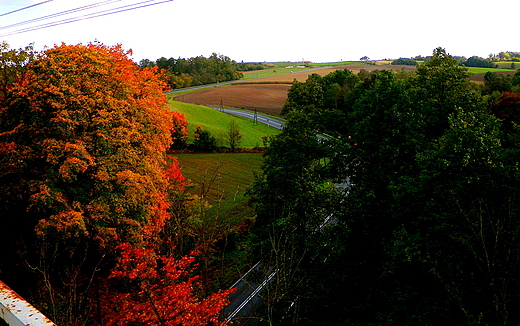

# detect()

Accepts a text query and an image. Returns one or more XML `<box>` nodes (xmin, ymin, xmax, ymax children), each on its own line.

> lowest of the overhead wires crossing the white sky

<box><xmin>0</xmin><ymin>0</ymin><xmax>173</xmax><ymax>37</ymax></box>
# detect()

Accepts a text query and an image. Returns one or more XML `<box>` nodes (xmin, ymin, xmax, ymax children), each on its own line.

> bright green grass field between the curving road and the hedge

<box><xmin>169</xmin><ymin>101</ymin><xmax>280</xmax><ymax>148</ymax></box>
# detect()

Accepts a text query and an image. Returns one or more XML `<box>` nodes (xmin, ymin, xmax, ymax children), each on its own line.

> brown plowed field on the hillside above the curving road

<box><xmin>175</xmin><ymin>65</ymin><xmax>415</xmax><ymax>116</ymax></box>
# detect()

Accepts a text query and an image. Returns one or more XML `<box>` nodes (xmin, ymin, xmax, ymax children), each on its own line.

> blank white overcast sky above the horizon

<box><xmin>0</xmin><ymin>0</ymin><xmax>520</xmax><ymax>62</ymax></box>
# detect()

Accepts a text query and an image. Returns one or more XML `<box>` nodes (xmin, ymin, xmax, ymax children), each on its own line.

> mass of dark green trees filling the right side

<box><xmin>250</xmin><ymin>48</ymin><xmax>520</xmax><ymax>325</ymax></box>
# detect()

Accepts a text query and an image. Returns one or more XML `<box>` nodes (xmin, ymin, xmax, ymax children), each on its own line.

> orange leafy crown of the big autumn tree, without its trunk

<box><xmin>0</xmin><ymin>43</ymin><xmax>183</xmax><ymax>243</ymax></box>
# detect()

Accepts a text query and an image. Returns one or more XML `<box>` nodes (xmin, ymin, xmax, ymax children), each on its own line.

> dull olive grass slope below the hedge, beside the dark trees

<box><xmin>175</xmin><ymin>153</ymin><xmax>263</xmax><ymax>290</ymax></box>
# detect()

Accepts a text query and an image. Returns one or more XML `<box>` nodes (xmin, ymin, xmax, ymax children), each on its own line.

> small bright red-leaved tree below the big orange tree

<box><xmin>102</xmin><ymin>243</ymin><xmax>232</xmax><ymax>326</ymax></box>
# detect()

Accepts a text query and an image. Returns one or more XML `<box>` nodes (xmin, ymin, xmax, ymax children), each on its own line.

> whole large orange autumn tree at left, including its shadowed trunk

<box><xmin>0</xmin><ymin>43</ymin><xmax>230</xmax><ymax>325</ymax></box>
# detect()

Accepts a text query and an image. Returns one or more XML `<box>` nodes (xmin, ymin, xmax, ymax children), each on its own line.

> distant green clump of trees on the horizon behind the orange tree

<box><xmin>139</xmin><ymin>53</ymin><xmax>265</xmax><ymax>89</ymax></box>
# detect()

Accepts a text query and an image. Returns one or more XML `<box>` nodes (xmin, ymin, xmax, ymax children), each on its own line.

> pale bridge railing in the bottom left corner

<box><xmin>0</xmin><ymin>281</ymin><xmax>56</xmax><ymax>326</ymax></box>
